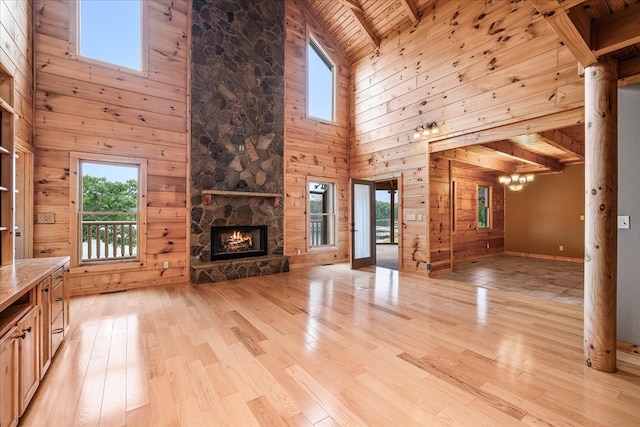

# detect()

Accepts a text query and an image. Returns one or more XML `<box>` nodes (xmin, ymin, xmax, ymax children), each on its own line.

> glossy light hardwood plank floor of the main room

<box><xmin>21</xmin><ymin>264</ymin><xmax>640</xmax><ymax>426</ymax></box>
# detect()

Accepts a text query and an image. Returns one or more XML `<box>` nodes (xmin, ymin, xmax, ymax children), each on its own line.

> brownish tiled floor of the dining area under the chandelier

<box><xmin>438</xmin><ymin>255</ymin><xmax>584</xmax><ymax>306</ymax></box>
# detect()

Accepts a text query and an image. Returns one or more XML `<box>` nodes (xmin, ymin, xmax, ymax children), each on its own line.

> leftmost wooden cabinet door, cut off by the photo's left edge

<box><xmin>0</xmin><ymin>327</ymin><xmax>19</xmax><ymax>427</ymax></box>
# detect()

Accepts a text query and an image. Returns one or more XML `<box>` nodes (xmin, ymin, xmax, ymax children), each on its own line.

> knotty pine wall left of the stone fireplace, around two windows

<box><xmin>34</xmin><ymin>0</ymin><xmax>190</xmax><ymax>294</ymax></box>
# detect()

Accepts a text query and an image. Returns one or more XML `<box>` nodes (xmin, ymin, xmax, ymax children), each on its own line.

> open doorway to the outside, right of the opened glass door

<box><xmin>375</xmin><ymin>179</ymin><xmax>400</xmax><ymax>270</ymax></box>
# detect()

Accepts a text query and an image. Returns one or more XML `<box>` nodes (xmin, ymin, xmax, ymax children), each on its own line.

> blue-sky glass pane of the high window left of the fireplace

<box><xmin>77</xmin><ymin>0</ymin><xmax>144</xmax><ymax>70</ymax></box>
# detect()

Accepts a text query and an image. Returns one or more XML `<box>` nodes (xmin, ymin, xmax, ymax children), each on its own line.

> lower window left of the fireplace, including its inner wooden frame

<box><xmin>72</xmin><ymin>154</ymin><xmax>146</xmax><ymax>265</ymax></box>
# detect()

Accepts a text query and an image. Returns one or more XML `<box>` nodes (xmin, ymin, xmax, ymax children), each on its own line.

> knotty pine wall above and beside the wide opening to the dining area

<box><xmin>349</xmin><ymin>0</ymin><xmax>584</xmax><ymax>272</ymax></box>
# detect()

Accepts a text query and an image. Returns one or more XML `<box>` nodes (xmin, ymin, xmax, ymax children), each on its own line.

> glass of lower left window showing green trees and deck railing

<box><xmin>79</xmin><ymin>161</ymin><xmax>140</xmax><ymax>263</ymax></box>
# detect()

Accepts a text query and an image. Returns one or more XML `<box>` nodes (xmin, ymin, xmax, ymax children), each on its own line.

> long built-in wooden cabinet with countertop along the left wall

<box><xmin>0</xmin><ymin>257</ymin><xmax>69</xmax><ymax>427</ymax></box>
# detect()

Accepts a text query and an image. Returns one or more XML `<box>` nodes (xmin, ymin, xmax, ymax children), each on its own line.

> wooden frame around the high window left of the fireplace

<box><xmin>69</xmin><ymin>0</ymin><xmax>149</xmax><ymax>73</ymax></box>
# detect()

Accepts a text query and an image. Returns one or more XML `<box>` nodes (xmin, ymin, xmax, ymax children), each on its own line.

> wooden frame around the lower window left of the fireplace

<box><xmin>69</xmin><ymin>152</ymin><xmax>147</xmax><ymax>271</ymax></box>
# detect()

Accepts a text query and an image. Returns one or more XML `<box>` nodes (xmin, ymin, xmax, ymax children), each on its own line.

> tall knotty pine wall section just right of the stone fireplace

<box><xmin>284</xmin><ymin>0</ymin><xmax>350</xmax><ymax>268</ymax></box>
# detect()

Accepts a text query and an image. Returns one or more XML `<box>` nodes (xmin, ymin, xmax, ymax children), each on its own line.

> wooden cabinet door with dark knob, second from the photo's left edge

<box><xmin>18</xmin><ymin>307</ymin><xmax>40</xmax><ymax>415</ymax></box>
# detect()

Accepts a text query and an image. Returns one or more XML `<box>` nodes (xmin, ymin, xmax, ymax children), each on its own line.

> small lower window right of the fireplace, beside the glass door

<box><xmin>309</xmin><ymin>181</ymin><xmax>336</xmax><ymax>248</ymax></box>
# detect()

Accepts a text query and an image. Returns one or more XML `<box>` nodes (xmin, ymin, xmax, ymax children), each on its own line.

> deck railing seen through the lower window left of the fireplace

<box><xmin>80</xmin><ymin>212</ymin><xmax>137</xmax><ymax>262</ymax></box>
